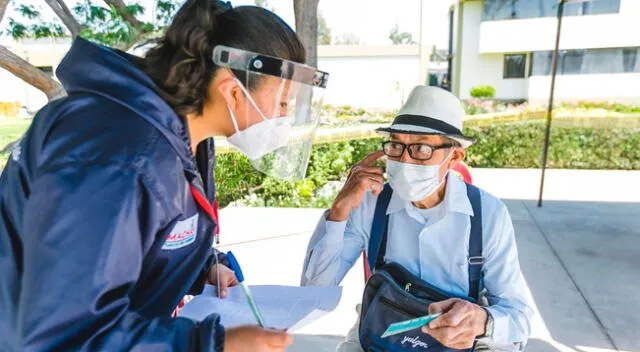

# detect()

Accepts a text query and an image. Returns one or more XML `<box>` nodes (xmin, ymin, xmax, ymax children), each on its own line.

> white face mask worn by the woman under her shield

<box><xmin>227</xmin><ymin>79</ymin><xmax>292</xmax><ymax>160</ymax></box>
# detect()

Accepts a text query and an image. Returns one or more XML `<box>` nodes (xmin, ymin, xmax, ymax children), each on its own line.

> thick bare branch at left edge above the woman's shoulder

<box><xmin>0</xmin><ymin>45</ymin><xmax>65</xmax><ymax>100</ymax></box>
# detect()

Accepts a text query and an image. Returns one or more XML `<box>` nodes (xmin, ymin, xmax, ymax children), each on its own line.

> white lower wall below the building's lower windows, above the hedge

<box><xmin>528</xmin><ymin>73</ymin><xmax>640</xmax><ymax>105</ymax></box>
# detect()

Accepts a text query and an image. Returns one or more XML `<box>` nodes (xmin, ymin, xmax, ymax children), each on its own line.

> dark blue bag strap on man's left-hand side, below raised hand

<box><xmin>367</xmin><ymin>183</ymin><xmax>393</xmax><ymax>271</ymax></box>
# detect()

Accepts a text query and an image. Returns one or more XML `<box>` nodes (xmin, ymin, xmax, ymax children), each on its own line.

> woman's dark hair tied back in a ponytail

<box><xmin>142</xmin><ymin>0</ymin><xmax>306</xmax><ymax>116</ymax></box>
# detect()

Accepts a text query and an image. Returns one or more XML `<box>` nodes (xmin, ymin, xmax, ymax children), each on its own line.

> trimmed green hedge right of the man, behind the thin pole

<box><xmin>466</xmin><ymin>121</ymin><xmax>640</xmax><ymax>170</ymax></box>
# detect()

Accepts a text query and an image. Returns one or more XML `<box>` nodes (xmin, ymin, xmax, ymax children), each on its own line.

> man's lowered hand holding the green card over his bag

<box><xmin>422</xmin><ymin>298</ymin><xmax>487</xmax><ymax>349</ymax></box>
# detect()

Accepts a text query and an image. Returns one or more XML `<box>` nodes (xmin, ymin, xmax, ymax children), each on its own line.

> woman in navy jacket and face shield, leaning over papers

<box><xmin>0</xmin><ymin>0</ymin><xmax>327</xmax><ymax>351</ymax></box>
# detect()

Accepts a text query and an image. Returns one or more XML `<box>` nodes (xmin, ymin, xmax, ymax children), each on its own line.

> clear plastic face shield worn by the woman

<box><xmin>213</xmin><ymin>45</ymin><xmax>329</xmax><ymax>180</ymax></box>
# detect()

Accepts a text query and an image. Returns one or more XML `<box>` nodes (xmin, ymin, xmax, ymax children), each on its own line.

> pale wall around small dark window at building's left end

<box><xmin>459</xmin><ymin>1</ymin><xmax>529</xmax><ymax>99</ymax></box>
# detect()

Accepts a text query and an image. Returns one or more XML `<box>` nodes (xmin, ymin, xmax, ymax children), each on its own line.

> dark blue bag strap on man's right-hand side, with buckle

<box><xmin>466</xmin><ymin>183</ymin><xmax>484</xmax><ymax>299</ymax></box>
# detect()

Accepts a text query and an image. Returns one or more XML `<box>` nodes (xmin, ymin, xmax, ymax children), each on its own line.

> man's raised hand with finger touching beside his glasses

<box><xmin>327</xmin><ymin>150</ymin><xmax>384</xmax><ymax>221</ymax></box>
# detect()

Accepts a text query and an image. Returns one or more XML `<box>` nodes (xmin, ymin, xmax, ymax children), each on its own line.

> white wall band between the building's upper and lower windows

<box><xmin>480</xmin><ymin>0</ymin><xmax>640</xmax><ymax>53</ymax></box>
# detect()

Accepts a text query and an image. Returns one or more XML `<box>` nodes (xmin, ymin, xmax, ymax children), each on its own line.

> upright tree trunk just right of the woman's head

<box><xmin>293</xmin><ymin>0</ymin><xmax>319</xmax><ymax>67</ymax></box>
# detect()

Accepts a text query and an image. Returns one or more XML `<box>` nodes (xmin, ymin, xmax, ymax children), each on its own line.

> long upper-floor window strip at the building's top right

<box><xmin>482</xmin><ymin>0</ymin><xmax>620</xmax><ymax>21</ymax></box>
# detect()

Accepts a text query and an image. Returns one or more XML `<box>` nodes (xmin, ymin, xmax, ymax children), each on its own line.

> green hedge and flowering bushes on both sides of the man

<box><xmin>216</xmin><ymin>121</ymin><xmax>640</xmax><ymax>207</ymax></box>
